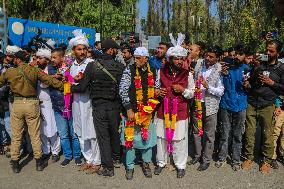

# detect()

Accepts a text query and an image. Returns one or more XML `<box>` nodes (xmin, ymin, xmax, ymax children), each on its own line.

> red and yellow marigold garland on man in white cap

<box><xmin>125</xmin><ymin>64</ymin><xmax>159</xmax><ymax>148</ymax></box>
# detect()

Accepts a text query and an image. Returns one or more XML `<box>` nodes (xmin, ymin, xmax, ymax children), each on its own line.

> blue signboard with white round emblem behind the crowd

<box><xmin>8</xmin><ymin>17</ymin><xmax>96</xmax><ymax>47</ymax></box>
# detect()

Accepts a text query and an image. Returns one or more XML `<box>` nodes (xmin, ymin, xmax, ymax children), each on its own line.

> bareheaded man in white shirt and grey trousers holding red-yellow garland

<box><xmin>193</xmin><ymin>46</ymin><xmax>224</xmax><ymax>171</ymax></box>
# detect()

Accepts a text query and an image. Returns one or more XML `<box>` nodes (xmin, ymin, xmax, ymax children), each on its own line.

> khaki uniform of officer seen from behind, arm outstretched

<box><xmin>0</xmin><ymin>63</ymin><xmax>63</xmax><ymax>161</ymax></box>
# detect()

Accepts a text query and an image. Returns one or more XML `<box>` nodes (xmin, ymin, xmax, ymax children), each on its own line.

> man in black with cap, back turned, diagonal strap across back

<box><xmin>71</xmin><ymin>39</ymin><xmax>124</xmax><ymax>177</ymax></box>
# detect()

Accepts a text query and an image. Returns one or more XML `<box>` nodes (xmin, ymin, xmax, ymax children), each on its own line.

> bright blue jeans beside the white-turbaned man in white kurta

<box><xmin>54</xmin><ymin>111</ymin><xmax>81</xmax><ymax>160</ymax></box>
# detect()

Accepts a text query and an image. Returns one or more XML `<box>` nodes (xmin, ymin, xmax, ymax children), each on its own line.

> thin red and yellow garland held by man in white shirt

<box><xmin>194</xmin><ymin>76</ymin><xmax>203</xmax><ymax>136</ymax></box>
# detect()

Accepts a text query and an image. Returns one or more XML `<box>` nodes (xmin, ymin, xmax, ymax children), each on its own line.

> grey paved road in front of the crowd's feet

<box><xmin>0</xmin><ymin>156</ymin><xmax>284</xmax><ymax>189</ymax></box>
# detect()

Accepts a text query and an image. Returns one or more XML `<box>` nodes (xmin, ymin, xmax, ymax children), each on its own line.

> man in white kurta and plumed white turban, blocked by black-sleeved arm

<box><xmin>69</xmin><ymin>29</ymin><xmax>101</xmax><ymax>174</ymax></box>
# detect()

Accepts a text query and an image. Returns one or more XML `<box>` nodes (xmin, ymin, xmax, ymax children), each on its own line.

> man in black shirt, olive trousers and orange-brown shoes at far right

<box><xmin>242</xmin><ymin>40</ymin><xmax>284</xmax><ymax>173</ymax></box>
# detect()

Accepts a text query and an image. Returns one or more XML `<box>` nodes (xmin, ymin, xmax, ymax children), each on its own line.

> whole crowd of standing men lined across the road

<box><xmin>0</xmin><ymin>30</ymin><xmax>284</xmax><ymax>180</ymax></box>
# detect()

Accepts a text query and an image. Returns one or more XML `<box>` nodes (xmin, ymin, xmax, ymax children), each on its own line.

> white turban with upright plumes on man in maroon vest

<box><xmin>166</xmin><ymin>33</ymin><xmax>188</xmax><ymax>58</ymax></box>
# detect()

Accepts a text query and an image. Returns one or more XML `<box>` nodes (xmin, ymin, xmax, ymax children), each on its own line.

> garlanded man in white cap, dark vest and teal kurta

<box><xmin>119</xmin><ymin>47</ymin><xmax>159</xmax><ymax>180</ymax></box>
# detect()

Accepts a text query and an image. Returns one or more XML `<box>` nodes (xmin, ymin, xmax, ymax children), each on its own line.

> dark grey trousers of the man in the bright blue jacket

<box><xmin>218</xmin><ymin>108</ymin><xmax>246</xmax><ymax>164</ymax></box>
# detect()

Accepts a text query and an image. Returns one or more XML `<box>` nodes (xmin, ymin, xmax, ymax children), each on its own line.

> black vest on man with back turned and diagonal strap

<box><xmin>90</xmin><ymin>55</ymin><xmax>124</xmax><ymax>101</ymax></box>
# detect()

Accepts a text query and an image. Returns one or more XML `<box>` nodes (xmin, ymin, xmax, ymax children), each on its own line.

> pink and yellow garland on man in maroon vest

<box><xmin>164</xmin><ymin>97</ymin><xmax>178</xmax><ymax>153</ymax></box>
